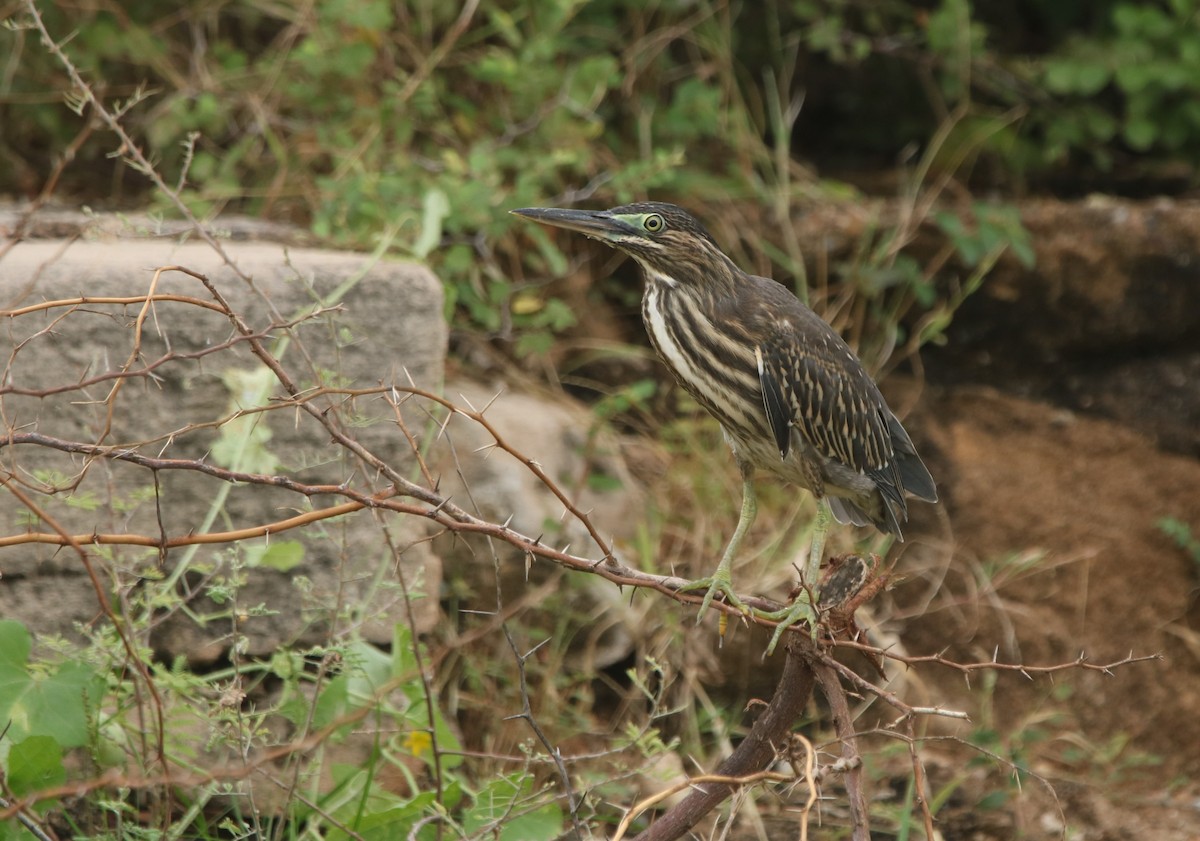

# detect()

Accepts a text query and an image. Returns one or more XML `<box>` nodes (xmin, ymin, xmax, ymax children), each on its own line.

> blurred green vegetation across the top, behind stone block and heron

<box><xmin>14</xmin><ymin>0</ymin><xmax>1200</xmax><ymax>364</ymax></box>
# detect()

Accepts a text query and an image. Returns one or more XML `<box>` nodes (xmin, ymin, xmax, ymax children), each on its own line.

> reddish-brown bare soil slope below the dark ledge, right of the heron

<box><xmin>896</xmin><ymin>388</ymin><xmax>1200</xmax><ymax>840</ymax></box>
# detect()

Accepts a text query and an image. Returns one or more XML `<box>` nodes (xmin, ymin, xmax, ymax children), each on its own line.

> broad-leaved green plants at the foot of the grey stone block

<box><xmin>0</xmin><ymin>621</ymin><xmax>564</xmax><ymax>841</ymax></box>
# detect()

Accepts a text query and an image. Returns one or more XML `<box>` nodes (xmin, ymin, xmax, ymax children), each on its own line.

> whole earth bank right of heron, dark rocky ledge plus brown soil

<box><xmin>898</xmin><ymin>200</ymin><xmax>1200</xmax><ymax>840</ymax></box>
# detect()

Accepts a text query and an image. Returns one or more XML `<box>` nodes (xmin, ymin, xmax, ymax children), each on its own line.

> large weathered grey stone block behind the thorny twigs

<box><xmin>0</xmin><ymin>239</ymin><xmax>446</xmax><ymax>660</ymax></box>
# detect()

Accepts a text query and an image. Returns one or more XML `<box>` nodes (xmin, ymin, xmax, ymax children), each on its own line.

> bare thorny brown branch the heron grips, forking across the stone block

<box><xmin>0</xmin><ymin>286</ymin><xmax>1158</xmax><ymax>662</ymax></box>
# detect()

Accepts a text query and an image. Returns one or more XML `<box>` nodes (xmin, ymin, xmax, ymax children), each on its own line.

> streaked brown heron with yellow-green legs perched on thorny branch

<box><xmin>512</xmin><ymin>202</ymin><xmax>937</xmax><ymax>651</ymax></box>
